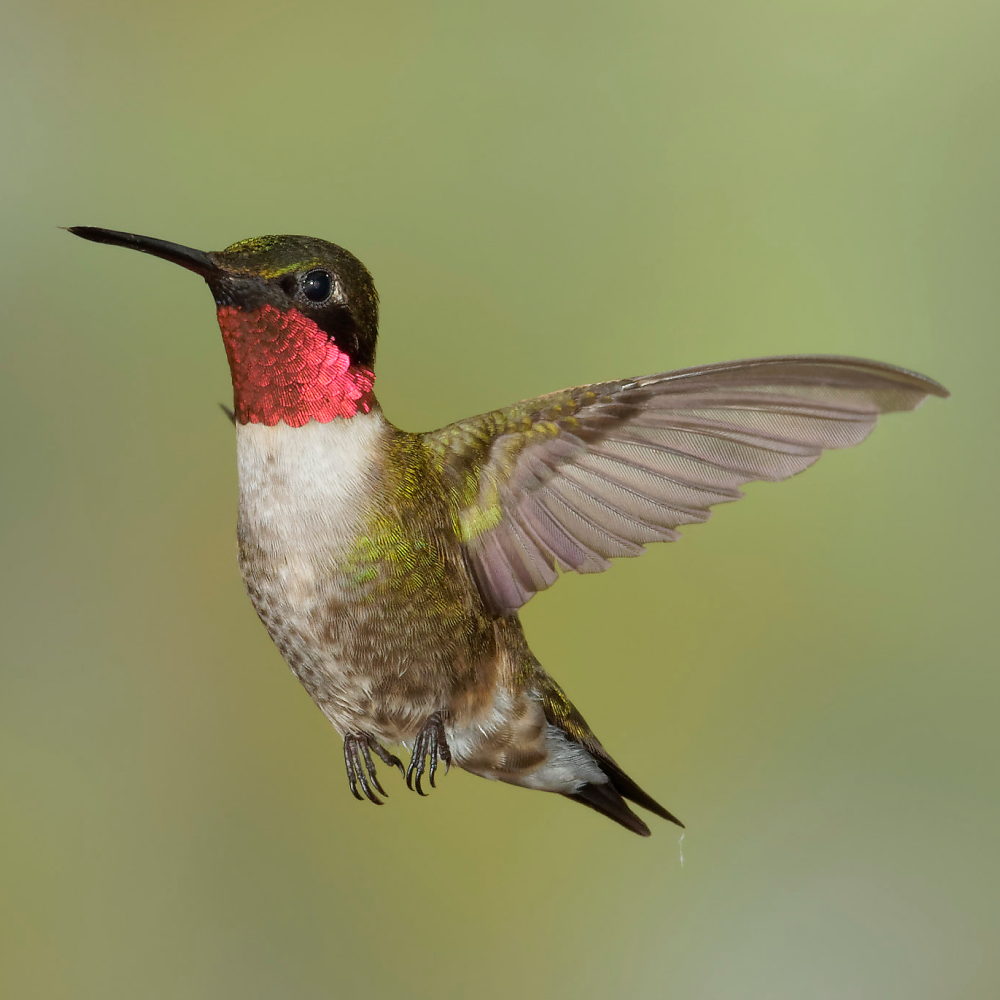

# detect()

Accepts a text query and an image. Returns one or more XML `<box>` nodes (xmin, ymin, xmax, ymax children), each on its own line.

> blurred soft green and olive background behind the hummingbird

<box><xmin>0</xmin><ymin>0</ymin><xmax>1000</xmax><ymax>1000</ymax></box>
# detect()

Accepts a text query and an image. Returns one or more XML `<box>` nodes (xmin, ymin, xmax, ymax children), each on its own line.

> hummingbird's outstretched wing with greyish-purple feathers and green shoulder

<box><xmin>425</xmin><ymin>356</ymin><xmax>948</xmax><ymax>613</ymax></box>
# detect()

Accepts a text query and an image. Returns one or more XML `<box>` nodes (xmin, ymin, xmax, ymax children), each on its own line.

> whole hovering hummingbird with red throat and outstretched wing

<box><xmin>69</xmin><ymin>226</ymin><xmax>948</xmax><ymax>836</ymax></box>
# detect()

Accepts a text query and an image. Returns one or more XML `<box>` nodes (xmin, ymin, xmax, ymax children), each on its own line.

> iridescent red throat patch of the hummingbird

<box><xmin>218</xmin><ymin>305</ymin><xmax>375</xmax><ymax>427</ymax></box>
